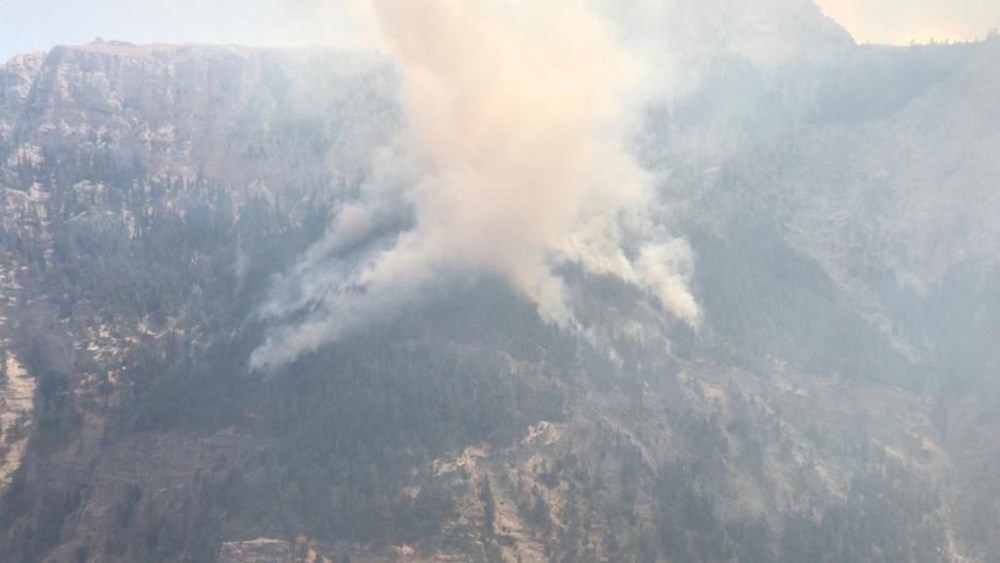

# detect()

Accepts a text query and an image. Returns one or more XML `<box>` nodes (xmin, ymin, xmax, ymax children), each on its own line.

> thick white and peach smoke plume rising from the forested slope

<box><xmin>251</xmin><ymin>0</ymin><xmax>700</xmax><ymax>369</ymax></box>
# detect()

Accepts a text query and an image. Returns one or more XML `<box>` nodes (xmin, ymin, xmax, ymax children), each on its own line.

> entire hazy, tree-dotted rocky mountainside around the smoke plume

<box><xmin>0</xmin><ymin>19</ymin><xmax>1000</xmax><ymax>562</ymax></box>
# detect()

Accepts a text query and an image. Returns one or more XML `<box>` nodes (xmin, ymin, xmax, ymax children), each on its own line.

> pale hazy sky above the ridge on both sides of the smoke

<box><xmin>0</xmin><ymin>0</ymin><xmax>1000</xmax><ymax>61</ymax></box>
